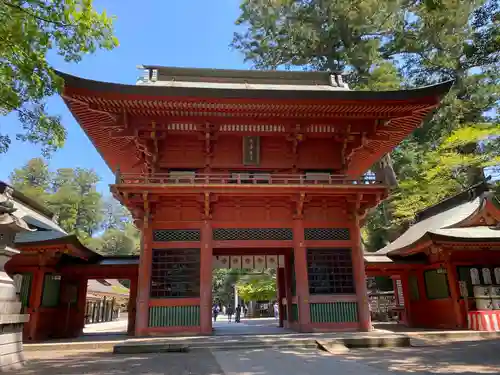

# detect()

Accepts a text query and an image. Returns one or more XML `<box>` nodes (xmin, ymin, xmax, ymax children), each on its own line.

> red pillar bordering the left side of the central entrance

<box><xmin>200</xmin><ymin>220</ymin><xmax>213</xmax><ymax>335</ymax></box>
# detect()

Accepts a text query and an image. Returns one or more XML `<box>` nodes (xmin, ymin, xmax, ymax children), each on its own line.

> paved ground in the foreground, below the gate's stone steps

<box><xmin>12</xmin><ymin>339</ymin><xmax>500</xmax><ymax>375</ymax></box>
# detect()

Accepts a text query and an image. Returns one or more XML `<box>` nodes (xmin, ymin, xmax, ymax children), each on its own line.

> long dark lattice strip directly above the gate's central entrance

<box><xmin>213</xmin><ymin>228</ymin><xmax>293</xmax><ymax>241</ymax></box>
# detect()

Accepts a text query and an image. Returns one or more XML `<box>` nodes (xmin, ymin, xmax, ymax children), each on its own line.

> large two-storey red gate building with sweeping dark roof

<box><xmin>8</xmin><ymin>66</ymin><xmax>451</xmax><ymax>335</ymax></box>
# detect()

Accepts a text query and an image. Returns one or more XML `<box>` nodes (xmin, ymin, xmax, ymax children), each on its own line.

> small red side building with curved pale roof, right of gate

<box><xmin>365</xmin><ymin>183</ymin><xmax>500</xmax><ymax>330</ymax></box>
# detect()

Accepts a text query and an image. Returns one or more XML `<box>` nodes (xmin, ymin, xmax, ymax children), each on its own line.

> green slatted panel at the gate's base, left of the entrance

<box><xmin>149</xmin><ymin>306</ymin><xmax>200</xmax><ymax>327</ymax></box>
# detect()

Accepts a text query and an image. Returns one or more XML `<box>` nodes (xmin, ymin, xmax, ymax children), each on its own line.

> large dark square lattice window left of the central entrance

<box><xmin>151</xmin><ymin>249</ymin><xmax>200</xmax><ymax>298</ymax></box>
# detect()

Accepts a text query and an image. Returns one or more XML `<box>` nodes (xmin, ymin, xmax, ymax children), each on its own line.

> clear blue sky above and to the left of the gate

<box><xmin>0</xmin><ymin>0</ymin><xmax>250</xmax><ymax>194</ymax></box>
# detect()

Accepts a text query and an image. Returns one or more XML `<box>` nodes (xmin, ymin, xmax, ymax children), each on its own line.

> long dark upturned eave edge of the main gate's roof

<box><xmin>55</xmin><ymin>70</ymin><xmax>454</xmax><ymax>101</ymax></box>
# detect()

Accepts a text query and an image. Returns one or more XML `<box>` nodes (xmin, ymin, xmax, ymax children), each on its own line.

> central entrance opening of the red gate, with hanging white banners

<box><xmin>212</xmin><ymin>249</ymin><xmax>287</xmax><ymax>335</ymax></box>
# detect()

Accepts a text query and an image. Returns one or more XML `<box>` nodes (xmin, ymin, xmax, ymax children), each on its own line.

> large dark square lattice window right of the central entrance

<box><xmin>307</xmin><ymin>249</ymin><xmax>355</xmax><ymax>294</ymax></box>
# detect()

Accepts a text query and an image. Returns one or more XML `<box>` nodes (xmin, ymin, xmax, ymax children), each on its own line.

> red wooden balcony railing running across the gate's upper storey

<box><xmin>115</xmin><ymin>173</ymin><xmax>381</xmax><ymax>185</ymax></box>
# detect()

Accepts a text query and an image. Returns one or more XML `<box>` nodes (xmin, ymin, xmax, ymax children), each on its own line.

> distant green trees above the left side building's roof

<box><xmin>10</xmin><ymin>158</ymin><xmax>140</xmax><ymax>255</ymax></box>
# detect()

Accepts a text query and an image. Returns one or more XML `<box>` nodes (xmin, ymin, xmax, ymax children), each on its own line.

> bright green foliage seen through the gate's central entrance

<box><xmin>236</xmin><ymin>270</ymin><xmax>276</xmax><ymax>301</ymax></box>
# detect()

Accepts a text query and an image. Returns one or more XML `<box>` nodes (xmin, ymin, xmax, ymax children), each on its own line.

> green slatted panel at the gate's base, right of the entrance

<box><xmin>309</xmin><ymin>302</ymin><xmax>358</xmax><ymax>323</ymax></box>
